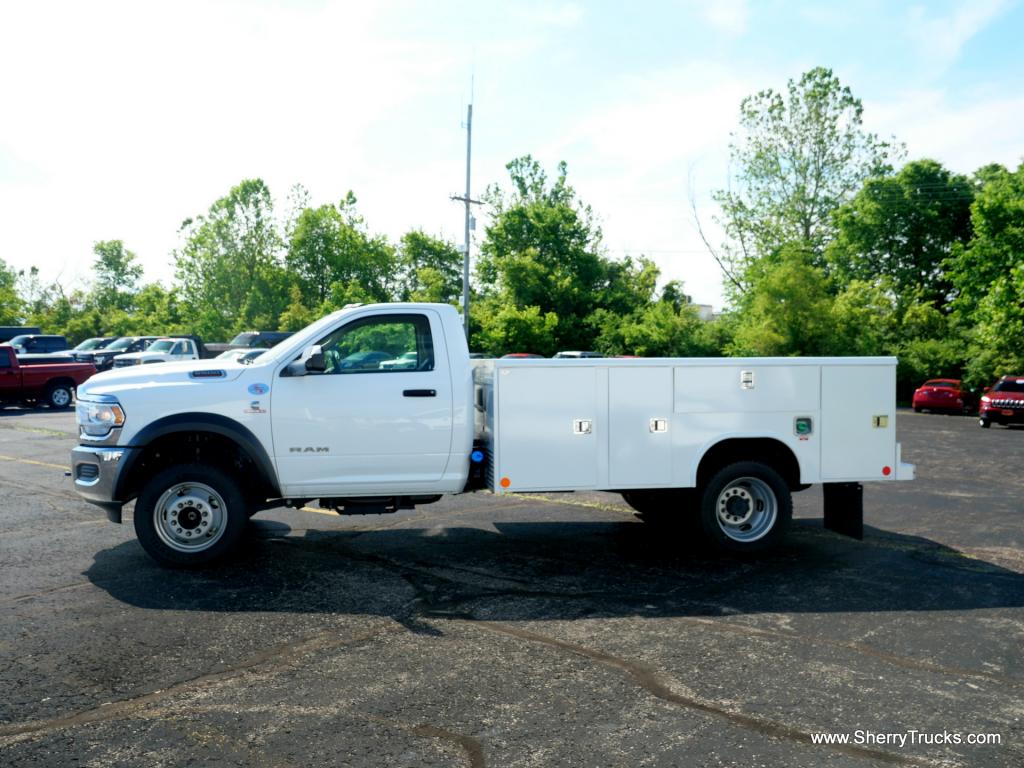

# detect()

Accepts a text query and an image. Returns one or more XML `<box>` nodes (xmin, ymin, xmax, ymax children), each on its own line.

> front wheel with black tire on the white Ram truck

<box><xmin>134</xmin><ymin>464</ymin><xmax>249</xmax><ymax>568</ymax></box>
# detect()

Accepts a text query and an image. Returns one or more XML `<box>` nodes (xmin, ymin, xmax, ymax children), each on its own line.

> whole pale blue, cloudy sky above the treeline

<box><xmin>0</xmin><ymin>0</ymin><xmax>1024</xmax><ymax>313</ymax></box>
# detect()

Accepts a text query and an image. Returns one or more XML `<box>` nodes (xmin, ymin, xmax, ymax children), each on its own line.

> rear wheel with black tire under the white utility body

<box><xmin>700</xmin><ymin>462</ymin><xmax>793</xmax><ymax>554</ymax></box>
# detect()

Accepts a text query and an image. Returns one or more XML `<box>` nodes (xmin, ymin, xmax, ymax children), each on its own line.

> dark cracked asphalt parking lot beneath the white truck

<box><xmin>0</xmin><ymin>408</ymin><xmax>1024</xmax><ymax>768</ymax></box>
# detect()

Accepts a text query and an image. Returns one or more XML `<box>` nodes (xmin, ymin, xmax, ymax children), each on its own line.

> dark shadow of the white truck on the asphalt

<box><xmin>85</xmin><ymin>519</ymin><xmax>1024</xmax><ymax>634</ymax></box>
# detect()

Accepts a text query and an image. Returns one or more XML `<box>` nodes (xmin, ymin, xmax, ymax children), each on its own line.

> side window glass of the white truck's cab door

<box><xmin>318</xmin><ymin>314</ymin><xmax>434</xmax><ymax>374</ymax></box>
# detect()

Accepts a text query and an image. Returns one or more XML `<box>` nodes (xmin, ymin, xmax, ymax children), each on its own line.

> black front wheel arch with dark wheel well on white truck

<box><xmin>114</xmin><ymin>413</ymin><xmax>281</xmax><ymax>500</ymax></box>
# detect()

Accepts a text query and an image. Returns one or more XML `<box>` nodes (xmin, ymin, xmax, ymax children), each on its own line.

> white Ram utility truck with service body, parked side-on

<box><xmin>72</xmin><ymin>304</ymin><xmax>913</xmax><ymax>566</ymax></box>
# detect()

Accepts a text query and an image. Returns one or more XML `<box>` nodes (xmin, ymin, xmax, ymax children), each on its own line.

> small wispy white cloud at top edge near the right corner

<box><xmin>906</xmin><ymin>0</ymin><xmax>1010</xmax><ymax>69</ymax></box>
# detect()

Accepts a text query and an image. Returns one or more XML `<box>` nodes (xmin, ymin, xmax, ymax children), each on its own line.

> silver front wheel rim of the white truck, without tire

<box><xmin>153</xmin><ymin>482</ymin><xmax>227</xmax><ymax>553</ymax></box>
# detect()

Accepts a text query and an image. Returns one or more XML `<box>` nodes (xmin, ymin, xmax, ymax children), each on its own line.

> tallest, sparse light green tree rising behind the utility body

<box><xmin>714</xmin><ymin>67</ymin><xmax>902</xmax><ymax>293</ymax></box>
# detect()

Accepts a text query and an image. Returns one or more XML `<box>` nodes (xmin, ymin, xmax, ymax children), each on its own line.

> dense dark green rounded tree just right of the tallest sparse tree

<box><xmin>826</xmin><ymin>160</ymin><xmax>974</xmax><ymax>308</ymax></box>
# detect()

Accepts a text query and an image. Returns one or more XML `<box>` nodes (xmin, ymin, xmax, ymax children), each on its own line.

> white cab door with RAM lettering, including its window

<box><xmin>270</xmin><ymin>310</ymin><xmax>453</xmax><ymax>495</ymax></box>
